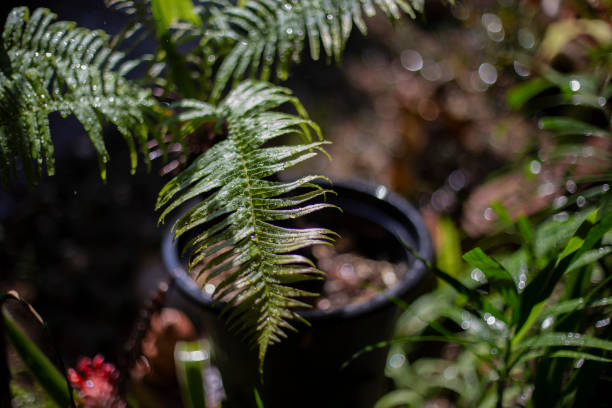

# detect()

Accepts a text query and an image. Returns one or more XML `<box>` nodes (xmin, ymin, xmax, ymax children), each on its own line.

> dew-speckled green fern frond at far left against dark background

<box><xmin>0</xmin><ymin>7</ymin><xmax>154</xmax><ymax>182</ymax></box>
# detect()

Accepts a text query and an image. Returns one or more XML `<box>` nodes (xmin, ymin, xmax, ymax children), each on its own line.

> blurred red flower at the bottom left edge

<box><xmin>68</xmin><ymin>354</ymin><xmax>127</xmax><ymax>408</ymax></box>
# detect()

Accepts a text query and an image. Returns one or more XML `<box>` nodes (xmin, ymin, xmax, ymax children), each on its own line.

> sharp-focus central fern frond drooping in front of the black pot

<box><xmin>157</xmin><ymin>81</ymin><xmax>333</xmax><ymax>362</ymax></box>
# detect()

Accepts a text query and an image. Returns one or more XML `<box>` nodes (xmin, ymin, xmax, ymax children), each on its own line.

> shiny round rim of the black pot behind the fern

<box><xmin>162</xmin><ymin>180</ymin><xmax>434</xmax><ymax>321</ymax></box>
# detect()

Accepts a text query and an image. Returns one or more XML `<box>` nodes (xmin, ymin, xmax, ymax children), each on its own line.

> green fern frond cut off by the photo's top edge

<box><xmin>209</xmin><ymin>0</ymin><xmax>424</xmax><ymax>97</ymax></box>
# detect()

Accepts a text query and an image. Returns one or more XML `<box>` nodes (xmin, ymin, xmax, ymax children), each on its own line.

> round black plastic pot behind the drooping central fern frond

<box><xmin>163</xmin><ymin>183</ymin><xmax>433</xmax><ymax>408</ymax></box>
